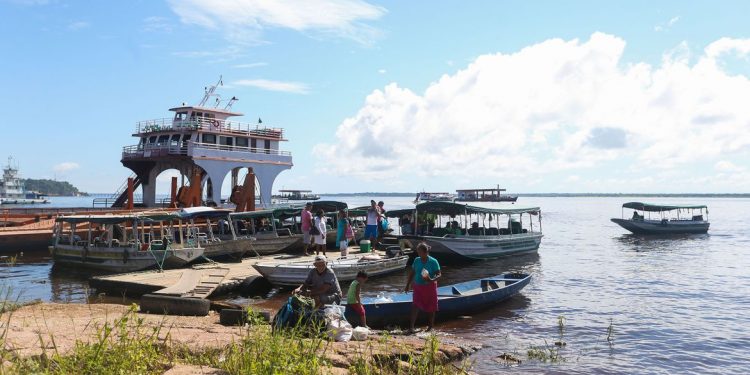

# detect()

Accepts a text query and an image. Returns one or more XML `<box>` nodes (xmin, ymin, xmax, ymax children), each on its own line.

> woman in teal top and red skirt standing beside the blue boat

<box><xmin>404</xmin><ymin>242</ymin><xmax>442</xmax><ymax>333</ymax></box>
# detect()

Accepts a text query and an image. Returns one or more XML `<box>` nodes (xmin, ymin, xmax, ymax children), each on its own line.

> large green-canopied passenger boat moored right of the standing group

<box><xmin>387</xmin><ymin>202</ymin><xmax>543</xmax><ymax>260</ymax></box>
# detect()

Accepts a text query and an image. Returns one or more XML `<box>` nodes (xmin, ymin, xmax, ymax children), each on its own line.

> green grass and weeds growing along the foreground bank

<box><xmin>0</xmin><ymin>305</ymin><xmax>468</xmax><ymax>375</ymax></box>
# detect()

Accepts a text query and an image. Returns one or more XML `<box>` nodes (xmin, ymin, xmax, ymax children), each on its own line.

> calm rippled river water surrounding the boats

<box><xmin>0</xmin><ymin>197</ymin><xmax>750</xmax><ymax>374</ymax></box>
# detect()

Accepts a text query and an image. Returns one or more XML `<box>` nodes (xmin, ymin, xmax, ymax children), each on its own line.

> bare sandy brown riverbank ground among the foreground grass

<box><xmin>0</xmin><ymin>303</ymin><xmax>474</xmax><ymax>374</ymax></box>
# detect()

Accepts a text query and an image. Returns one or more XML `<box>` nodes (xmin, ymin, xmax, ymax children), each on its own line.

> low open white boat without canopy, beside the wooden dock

<box><xmin>253</xmin><ymin>254</ymin><xmax>409</xmax><ymax>286</ymax></box>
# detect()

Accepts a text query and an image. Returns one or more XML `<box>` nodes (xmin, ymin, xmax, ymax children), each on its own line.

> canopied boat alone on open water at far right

<box><xmin>611</xmin><ymin>202</ymin><xmax>711</xmax><ymax>234</ymax></box>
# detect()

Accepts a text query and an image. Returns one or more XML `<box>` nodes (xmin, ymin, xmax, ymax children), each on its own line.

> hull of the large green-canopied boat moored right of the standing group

<box><xmin>398</xmin><ymin>233</ymin><xmax>543</xmax><ymax>260</ymax></box>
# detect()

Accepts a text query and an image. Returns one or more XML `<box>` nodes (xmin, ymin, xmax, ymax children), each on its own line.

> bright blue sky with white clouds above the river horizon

<box><xmin>0</xmin><ymin>0</ymin><xmax>750</xmax><ymax>193</ymax></box>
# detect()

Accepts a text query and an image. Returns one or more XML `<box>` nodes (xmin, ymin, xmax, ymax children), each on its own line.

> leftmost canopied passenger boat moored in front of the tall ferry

<box><xmin>49</xmin><ymin>212</ymin><xmax>204</xmax><ymax>273</ymax></box>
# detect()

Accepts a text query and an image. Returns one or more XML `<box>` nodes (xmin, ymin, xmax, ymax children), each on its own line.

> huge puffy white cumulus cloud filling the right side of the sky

<box><xmin>314</xmin><ymin>33</ymin><xmax>750</xmax><ymax>189</ymax></box>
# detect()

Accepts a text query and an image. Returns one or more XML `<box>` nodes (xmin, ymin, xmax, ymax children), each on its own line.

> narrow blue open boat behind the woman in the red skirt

<box><xmin>346</xmin><ymin>273</ymin><xmax>531</xmax><ymax>327</ymax></box>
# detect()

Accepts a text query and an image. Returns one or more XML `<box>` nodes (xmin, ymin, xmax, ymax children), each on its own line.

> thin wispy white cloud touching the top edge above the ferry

<box><xmin>169</xmin><ymin>0</ymin><xmax>386</xmax><ymax>44</ymax></box>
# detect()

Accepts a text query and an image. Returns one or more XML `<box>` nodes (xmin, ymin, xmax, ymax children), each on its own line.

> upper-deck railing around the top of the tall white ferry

<box><xmin>135</xmin><ymin>117</ymin><xmax>284</xmax><ymax>140</ymax></box>
